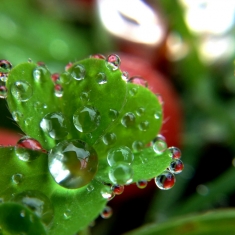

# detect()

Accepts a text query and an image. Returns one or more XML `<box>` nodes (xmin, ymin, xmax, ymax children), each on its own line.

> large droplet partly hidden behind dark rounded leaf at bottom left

<box><xmin>13</xmin><ymin>190</ymin><xmax>54</xmax><ymax>227</ymax></box>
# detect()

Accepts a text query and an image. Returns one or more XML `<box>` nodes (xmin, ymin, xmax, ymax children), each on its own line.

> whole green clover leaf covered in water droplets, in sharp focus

<box><xmin>0</xmin><ymin>54</ymin><xmax>183</xmax><ymax>235</ymax></box>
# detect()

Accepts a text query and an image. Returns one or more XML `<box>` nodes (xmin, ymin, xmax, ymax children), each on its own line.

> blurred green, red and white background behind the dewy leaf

<box><xmin>0</xmin><ymin>0</ymin><xmax>235</xmax><ymax>235</ymax></box>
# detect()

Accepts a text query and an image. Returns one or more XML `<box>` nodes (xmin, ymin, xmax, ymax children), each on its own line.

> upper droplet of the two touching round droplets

<box><xmin>107</xmin><ymin>146</ymin><xmax>134</xmax><ymax>166</ymax></box>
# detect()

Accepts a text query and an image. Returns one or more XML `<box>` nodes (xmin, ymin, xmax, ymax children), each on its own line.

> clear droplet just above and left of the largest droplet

<box><xmin>40</xmin><ymin>112</ymin><xmax>68</xmax><ymax>140</ymax></box>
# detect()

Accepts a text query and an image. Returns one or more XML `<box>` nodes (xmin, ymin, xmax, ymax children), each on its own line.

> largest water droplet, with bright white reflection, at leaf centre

<box><xmin>48</xmin><ymin>140</ymin><xmax>98</xmax><ymax>189</ymax></box>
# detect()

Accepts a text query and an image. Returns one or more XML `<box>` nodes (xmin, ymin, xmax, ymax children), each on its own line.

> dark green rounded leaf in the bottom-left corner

<box><xmin>0</xmin><ymin>202</ymin><xmax>47</xmax><ymax>235</ymax></box>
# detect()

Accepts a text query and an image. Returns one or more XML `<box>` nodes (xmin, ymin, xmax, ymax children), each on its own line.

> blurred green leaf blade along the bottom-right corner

<box><xmin>125</xmin><ymin>209</ymin><xmax>235</xmax><ymax>235</ymax></box>
